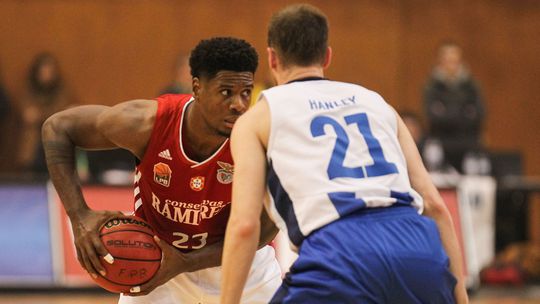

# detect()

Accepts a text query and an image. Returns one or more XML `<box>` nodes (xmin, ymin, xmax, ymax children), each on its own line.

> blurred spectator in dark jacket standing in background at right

<box><xmin>424</xmin><ymin>42</ymin><xmax>485</xmax><ymax>171</ymax></box>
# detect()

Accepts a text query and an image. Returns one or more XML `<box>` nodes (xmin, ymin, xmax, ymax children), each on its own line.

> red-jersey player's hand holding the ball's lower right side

<box><xmin>124</xmin><ymin>236</ymin><xmax>189</xmax><ymax>296</ymax></box>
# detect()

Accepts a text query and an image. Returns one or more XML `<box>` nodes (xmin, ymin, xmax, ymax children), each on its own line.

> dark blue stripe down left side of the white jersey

<box><xmin>266</xmin><ymin>161</ymin><xmax>305</xmax><ymax>247</ymax></box>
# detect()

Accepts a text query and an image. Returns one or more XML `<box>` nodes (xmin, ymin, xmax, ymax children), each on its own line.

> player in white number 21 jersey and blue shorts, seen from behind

<box><xmin>221</xmin><ymin>5</ymin><xmax>468</xmax><ymax>304</ymax></box>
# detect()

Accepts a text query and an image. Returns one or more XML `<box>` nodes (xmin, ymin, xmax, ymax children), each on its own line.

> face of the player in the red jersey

<box><xmin>196</xmin><ymin>71</ymin><xmax>253</xmax><ymax>137</ymax></box>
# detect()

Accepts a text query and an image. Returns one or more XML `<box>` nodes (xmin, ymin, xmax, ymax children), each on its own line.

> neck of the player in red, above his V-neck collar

<box><xmin>182</xmin><ymin>102</ymin><xmax>227</xmax><ymax>161</ymax></box>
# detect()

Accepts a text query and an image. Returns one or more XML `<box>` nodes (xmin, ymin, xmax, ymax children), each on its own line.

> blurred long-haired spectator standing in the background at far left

<box><xmin>17</xmin><ymin>52</ymin><xmax>73</xmax><ymax>174</ymax></box>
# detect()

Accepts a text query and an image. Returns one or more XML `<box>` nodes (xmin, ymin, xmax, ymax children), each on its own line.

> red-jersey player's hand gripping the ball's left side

<box><xmin>71</xmin><ymin>210</ymin><xmax>125</xmax><ymax>278</ymax></box>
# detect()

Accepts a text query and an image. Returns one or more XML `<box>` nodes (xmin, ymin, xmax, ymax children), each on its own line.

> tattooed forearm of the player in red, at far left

<box><xmin>42</xmin><ymin>116</ymin><xmax>88</xmax><ymax>221</ymax></box>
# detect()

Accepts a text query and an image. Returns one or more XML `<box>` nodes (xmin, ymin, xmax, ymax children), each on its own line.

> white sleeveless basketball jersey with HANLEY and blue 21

<box><xmin>261</xmin><ymin>80</ymin><xmax>423</xmax><ymax>249</ymax></box>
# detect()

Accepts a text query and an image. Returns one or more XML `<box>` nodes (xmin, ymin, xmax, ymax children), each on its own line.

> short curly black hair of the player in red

<box><xmin>189</xmin><ymin>37</ymin><xmax>259</xmax><ymax>79</ymax></box>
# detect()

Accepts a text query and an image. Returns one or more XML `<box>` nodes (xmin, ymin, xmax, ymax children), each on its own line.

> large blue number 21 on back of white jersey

<box><xmin>310</xmin><ymin>113</ymin><xmax>398</xmax><ymax>179</ymax></box>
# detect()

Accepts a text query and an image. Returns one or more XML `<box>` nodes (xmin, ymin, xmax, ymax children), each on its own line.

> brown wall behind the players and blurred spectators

<box><xmin>0</xmin><ymin>0</ymin><xmax>540</xmax><ymax>175</ymax></box>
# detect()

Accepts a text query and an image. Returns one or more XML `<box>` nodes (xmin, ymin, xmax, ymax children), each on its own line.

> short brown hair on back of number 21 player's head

<box><xmin>268</xmin><ymin>4</ymin><xmax>328</xmax><ymax>66</ymax></box>
